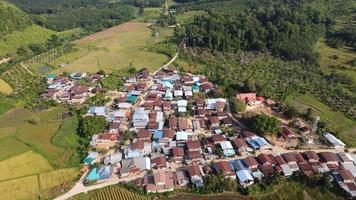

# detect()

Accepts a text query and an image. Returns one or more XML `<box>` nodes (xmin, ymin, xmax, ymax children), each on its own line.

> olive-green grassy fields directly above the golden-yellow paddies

<box><xmin>0</xmin><ymin>107</ymin><xmax>80</xmax><ymax>168</ymax></box>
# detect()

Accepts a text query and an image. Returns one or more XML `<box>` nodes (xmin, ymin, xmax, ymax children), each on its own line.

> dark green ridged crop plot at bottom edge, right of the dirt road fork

<box><xmin>71</xmin><ymin>186</ymin><xmax>147</xmax><ymax>200</ymax></box>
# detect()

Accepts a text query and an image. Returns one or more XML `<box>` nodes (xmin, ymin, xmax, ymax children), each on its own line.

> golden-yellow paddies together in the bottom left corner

<box><xmin>0</xmin><ymin>151</ymin><xmax>79</xmax><ymax>199</ymax></box>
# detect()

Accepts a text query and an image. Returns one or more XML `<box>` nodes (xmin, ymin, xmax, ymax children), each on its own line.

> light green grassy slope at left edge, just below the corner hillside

<box><xmin>0</xmin><ymin>25</ymin><xmax>56</xmax><ymax>56</ymax></box>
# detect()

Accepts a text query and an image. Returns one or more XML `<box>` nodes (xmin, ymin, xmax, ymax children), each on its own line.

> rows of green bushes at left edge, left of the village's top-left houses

<box><xmin>0</xmin><ymin>65</ymin><xmax>44</xmax><ymax>99</ymax></box>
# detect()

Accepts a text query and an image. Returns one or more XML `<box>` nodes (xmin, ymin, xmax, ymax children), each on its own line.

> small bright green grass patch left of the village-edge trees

<box><xmin>52</xmin><ymin>116</ymin><xmax>79</xmax><ymax>148</ymax></box>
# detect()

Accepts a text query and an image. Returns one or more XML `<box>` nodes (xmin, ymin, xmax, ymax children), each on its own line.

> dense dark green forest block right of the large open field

<box><xmin>177</xmin><ymin>1</ymin><xmax>331</xmax><ymax>62</ymax></box>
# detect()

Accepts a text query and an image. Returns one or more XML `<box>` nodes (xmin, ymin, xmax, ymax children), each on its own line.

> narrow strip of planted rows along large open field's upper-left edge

<box><xmin>25</xmin><ymin>44</ymin><xmax>75</xmax><ymax>65</ymax></box>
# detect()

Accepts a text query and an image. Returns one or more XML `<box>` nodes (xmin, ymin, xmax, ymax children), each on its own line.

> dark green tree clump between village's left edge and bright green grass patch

<box><xmin>79</xmin><ymin>116</ymin><xmax>108</xmax><ymax>137</ymax></box>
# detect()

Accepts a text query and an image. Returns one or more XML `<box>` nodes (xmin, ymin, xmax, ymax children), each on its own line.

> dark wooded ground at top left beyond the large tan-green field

<box><xmin>6</xmin><ymin>0</ymin><xmax>137</xmax><ymax>32</ymax></box>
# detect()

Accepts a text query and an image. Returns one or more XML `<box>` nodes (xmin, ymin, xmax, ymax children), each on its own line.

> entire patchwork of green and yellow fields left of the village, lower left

<box><xmin>0</xmin><ymin>107</ymin><xmax>79</xmax><ymax>199</ymax></box>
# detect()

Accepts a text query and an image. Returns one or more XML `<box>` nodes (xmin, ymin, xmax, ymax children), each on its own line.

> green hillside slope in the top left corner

<box><xmin>0</xmin><ymin>1</ymin><xmax>32</xmax><ymax>35</ymax></box>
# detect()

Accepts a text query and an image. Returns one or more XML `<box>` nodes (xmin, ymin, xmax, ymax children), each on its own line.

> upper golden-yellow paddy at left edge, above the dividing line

<box><xmin>0</xmin><ymin>151</ymin><xmax>53</xmax><ymax>181</ymax></box>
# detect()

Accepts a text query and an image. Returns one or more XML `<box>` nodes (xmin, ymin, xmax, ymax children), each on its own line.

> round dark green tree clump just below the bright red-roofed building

<box><xmin>251</xmin><ymin>114</ymin><xmax>279</xmax><ymax>135</ymax></box>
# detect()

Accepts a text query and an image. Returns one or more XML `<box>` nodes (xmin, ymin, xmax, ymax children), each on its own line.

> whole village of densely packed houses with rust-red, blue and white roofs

<box><xmin>42</xmin><ymin>67</ymin><xmax>356</xmax><ymax>197</ymax></box>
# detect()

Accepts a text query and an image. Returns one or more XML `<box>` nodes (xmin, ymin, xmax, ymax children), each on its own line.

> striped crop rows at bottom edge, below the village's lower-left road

<box><xmin>81</xmin><ymin>186</ymin><xmax>146</xmax><ymax>200</ymax></box>
